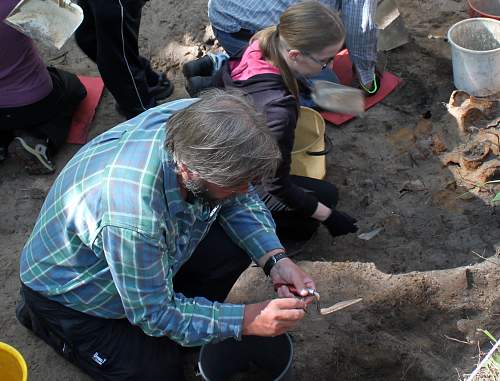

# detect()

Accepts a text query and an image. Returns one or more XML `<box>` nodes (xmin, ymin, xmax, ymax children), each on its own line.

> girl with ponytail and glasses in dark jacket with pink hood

<box><xmin>183</xmin><ymin>1</ymin><xmax>358</xmax><ymax>243</ymax></box>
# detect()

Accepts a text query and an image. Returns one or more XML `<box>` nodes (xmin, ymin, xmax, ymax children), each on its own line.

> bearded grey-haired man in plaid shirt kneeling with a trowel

<box><xmin>17</xmin><ymin>90</ymin><xmax>315</xmax><ymax>380</ymax></box>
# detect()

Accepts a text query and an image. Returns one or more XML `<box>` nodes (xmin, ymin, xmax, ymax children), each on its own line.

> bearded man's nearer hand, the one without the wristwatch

<box><xmin>243</xmin><ymin>298</ymin><xmax>306</xmax><ymax>336</ymax></box>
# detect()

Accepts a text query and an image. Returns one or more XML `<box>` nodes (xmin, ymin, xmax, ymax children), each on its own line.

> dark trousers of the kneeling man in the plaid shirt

<box><xmin>16</xmin><ymin>223</ymin><xmax>250</xmax><ymax>381</ymax></box>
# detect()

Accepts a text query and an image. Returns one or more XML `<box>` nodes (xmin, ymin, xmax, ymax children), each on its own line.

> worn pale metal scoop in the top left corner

<box><xmin>5</xmin><ymin>0</ymin><xmax>83</xmax><ymax>49</ymax></box>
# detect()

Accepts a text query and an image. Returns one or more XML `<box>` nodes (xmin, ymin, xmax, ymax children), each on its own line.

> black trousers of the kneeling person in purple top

<box><xmin>0</xmin><ymin>67</ymin><xmax>87</xmax><ymax>152</ymax></box>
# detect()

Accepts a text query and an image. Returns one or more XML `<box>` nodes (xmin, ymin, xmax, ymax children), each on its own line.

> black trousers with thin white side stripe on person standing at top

<box><xmin>75</xmin><ymin>0</ymin><xmax>159</xmax><ymax>116</ymax></box>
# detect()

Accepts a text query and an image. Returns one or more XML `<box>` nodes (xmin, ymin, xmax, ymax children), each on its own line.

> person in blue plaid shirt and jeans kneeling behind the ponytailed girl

<box><xmin>208</xmin><ymin>0</ymin><xmax>380</xmax><ymax>95</ymax></box>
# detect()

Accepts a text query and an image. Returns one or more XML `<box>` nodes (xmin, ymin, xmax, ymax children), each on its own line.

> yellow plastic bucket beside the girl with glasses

<box><xmin>290</xmin><ymin>107</ymin><xmax>331</xmax><ymax>180</ymax></box>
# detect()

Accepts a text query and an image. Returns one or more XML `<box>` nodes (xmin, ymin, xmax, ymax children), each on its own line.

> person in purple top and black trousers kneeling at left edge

<box><xmin>0</xmin><ymin>0</ymin><xmax>87</xmax><ymax>174</ymax></box>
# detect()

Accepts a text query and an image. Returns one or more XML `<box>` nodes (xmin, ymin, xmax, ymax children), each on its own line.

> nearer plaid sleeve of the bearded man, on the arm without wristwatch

<box><xmin>101</xmin><ymin>226</ymin><xmax>244</xmax><ymax>346</ymax></box>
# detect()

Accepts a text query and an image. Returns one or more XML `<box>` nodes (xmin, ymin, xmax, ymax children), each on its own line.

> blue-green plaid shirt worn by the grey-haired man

<box><xmin>21</xmin><ymin>99</ymin><xmax>282</xmax><ymax>345</ymax></box>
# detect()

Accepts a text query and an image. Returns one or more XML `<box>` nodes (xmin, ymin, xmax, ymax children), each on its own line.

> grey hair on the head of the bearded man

<box><xmin>165</xmin><ymin>89</ymin><xmax>281</xmax><ymax>187</ymax></box>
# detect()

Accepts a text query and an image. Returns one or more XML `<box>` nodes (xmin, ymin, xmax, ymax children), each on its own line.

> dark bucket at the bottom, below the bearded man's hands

<box><xmin>198</xmin><ymin>334</ymin><xmax>293</xmax><ymax>381</ymax></box>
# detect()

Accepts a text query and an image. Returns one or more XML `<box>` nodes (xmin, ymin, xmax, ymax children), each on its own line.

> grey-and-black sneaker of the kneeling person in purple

<box><xmin>14</xmin><ymin>135</ymin><xmax>56</xmax><ymax>175</ymax></box>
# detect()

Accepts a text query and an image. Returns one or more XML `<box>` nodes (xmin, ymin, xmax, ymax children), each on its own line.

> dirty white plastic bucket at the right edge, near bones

<box><xmin>448</xmin><ymin>18</ymin><xmax>500</xmax><ymax>97</ymax></box>
